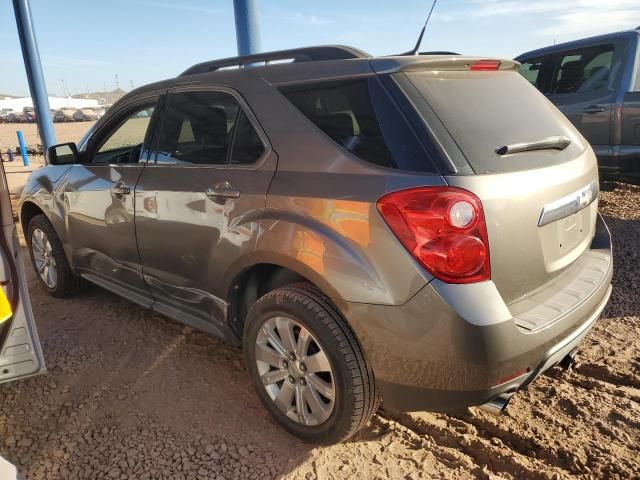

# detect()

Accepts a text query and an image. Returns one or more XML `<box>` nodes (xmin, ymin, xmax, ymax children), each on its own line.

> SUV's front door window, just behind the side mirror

<box><xmin>92</xmin><ymin>106</ymin><xmax>154</xmax><ymax>163</ymax></box>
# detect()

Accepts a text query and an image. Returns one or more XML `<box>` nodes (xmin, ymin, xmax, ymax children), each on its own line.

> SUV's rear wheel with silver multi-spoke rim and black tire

<box><xmin>244</xmin><ymin>283</ymin><xmax>379</xmax><ymax>444</ymax></box>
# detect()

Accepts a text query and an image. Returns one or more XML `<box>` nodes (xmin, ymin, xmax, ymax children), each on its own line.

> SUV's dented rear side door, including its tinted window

<box><xmin>136</xmin><ymin>89</ymin><xmax>276</xmax><ymax>335</ymax></box>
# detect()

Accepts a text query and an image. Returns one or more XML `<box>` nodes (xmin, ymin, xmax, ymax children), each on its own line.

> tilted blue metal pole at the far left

<box><xmin>13</xmin><ymin>0</ymin><xmax>56</xmax><ymax>158</ymax></box>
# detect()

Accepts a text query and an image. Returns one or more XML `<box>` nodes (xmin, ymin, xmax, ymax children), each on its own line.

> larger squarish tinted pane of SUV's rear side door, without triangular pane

<box><xmin>156</xmin><ymin>92</ymin><xmax>240</xmax><ymax>165</ymax></box>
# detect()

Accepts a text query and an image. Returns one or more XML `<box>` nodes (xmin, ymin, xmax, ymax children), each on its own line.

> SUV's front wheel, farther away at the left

<box><xmin>26</xmin><ymin>215</ymin><xmax>87</xmax><ymax>297</ymax></box>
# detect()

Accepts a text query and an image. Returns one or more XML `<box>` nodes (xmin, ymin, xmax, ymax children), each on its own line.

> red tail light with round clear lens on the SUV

<box><xmin>377</xmin><ymin>187</ymin><xmax>491</xmax><ymax>283</ymax></box>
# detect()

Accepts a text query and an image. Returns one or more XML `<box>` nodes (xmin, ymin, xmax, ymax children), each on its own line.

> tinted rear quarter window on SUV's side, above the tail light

<box><xmin>280</xmin><ymin>78</ymin><xmax>436</xmax><ymax>172</ymax></box>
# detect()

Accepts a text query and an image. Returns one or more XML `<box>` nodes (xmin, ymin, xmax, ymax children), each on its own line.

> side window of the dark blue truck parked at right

<box><xmin>552</xmin><ymin>44</ymin><xmax>620</xmax><ymax>94</ymax></box>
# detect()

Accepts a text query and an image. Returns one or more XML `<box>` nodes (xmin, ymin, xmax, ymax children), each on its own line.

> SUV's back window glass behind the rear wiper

<box><xmin>397</xmin><ymin>71</ymin><xmax>586</xmax><ymax>174</ymax></box>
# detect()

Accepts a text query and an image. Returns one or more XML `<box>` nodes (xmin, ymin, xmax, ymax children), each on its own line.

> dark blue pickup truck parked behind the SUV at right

<box><xmin>516</xmin><ymin>27</ymin><xmax>640</xmax><ymax>179</ymax></box>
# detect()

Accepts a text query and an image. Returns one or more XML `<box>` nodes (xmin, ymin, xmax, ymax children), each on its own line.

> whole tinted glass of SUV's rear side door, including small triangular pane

<box><xmin>156</xmin><ymin>91</ymin><xmax>265</xmax><ymax>165</ymax></box>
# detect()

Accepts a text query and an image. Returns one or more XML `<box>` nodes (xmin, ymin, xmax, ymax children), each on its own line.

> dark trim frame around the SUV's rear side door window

<box><xmin>145</xmin><ymin>85</ymin><xmax>273</xmax><ymax>170</ymax></box>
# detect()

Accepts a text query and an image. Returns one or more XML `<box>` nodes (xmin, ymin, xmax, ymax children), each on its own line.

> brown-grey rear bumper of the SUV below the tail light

<box><xmin>341</xmin><ymin>217</ymin><xmax>613</xmax><ymax>412</ymax></box>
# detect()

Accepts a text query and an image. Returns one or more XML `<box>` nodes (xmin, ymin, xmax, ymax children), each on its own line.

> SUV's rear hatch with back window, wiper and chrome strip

<box><xmin>384</xmin><ymin>57</ymin><xmax>598</xmax><ymax>303</ymax></box>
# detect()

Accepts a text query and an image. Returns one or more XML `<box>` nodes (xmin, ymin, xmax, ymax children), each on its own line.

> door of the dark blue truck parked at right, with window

<box><xmin>548</xmin><ymin>41</ymin><xmax>623</xmax><ymax>152</ymax></box>
